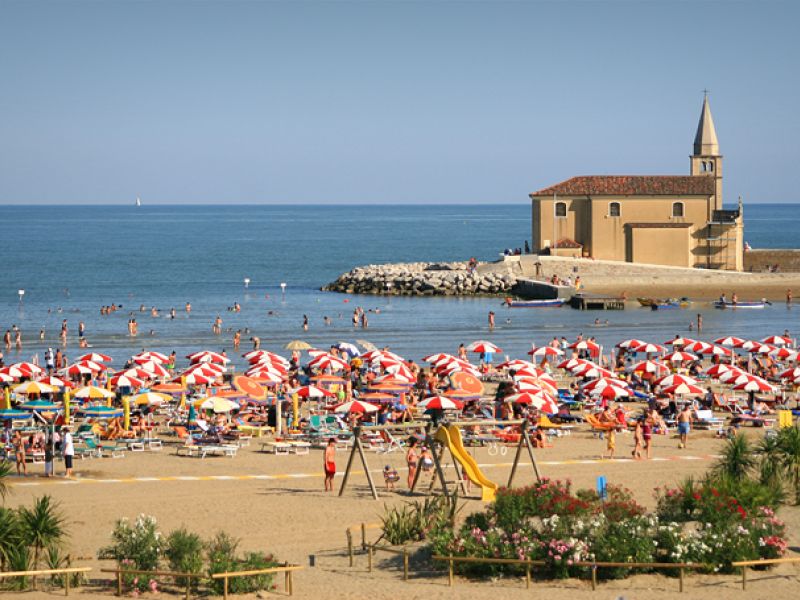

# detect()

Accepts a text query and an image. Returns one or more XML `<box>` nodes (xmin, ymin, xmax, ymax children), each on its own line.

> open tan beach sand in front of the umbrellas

<box><xmin>5</xmin><ymin>429</ymin><xmax>800</xmax><ymax>600</ymax></box>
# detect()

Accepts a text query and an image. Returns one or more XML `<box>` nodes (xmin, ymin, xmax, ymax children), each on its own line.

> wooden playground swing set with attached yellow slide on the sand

<box><xmin>339</xmin><ymin>419</ymin><xmax>541</xmax><ymax>502</ymax></box>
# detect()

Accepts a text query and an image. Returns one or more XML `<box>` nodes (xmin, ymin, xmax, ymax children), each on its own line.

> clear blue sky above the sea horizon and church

<box><xmin>0</xmin><ymin>0</ymin><xmax>800</xmax><ymax>204</ymax></box>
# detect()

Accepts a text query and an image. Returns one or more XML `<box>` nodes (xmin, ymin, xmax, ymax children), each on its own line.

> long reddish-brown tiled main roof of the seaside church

<box><xmin>531</xmin><ymin>175</ymin><xmax>714</xmax><ymax>196</ymax></box>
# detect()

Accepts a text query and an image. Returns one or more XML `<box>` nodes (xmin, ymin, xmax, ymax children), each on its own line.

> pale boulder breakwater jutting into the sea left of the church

<box><xmin>322</xmin><ymin>262</ymin><xmax>517</xmax><ymax>296</ymax></box>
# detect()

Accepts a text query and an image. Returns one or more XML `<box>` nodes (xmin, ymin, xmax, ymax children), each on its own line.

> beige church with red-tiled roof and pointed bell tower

<box><xmin>530</xmin><ymin>97</ymin><xmax>744</xmax><ymax>271</ymax></box>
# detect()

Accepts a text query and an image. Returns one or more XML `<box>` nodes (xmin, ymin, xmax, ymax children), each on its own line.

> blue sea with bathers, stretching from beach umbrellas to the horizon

<box><xmin>0</xmin><ymin>202</ymin><xmax>800</xmax><ymax>368</ymax></box>
